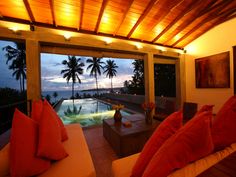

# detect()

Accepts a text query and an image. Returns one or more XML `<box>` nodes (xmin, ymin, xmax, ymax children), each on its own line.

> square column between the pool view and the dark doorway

<box><xmin>144</xmin><ymin>53</ymin><xmax>155</xmax><ymax>103</ymax></box>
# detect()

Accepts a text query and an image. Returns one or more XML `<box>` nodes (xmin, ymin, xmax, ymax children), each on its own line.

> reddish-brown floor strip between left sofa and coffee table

<box><xmin>84</xmin><ymin>126</ymin><xmax>118</xmax><ymax>177</ymax></box>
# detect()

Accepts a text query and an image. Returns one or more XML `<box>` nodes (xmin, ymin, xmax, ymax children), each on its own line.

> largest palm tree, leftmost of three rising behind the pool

<box><xmin>61</xmin><ymin>56</ymin><xmax>84</xmax><ymax>100</ymax></box>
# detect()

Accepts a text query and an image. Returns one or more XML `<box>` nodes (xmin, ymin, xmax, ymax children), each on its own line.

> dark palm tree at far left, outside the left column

<box><xmin>2</xmin><ymin>43</ymin><xmax>26</xmax><ymax>92</ymax></box>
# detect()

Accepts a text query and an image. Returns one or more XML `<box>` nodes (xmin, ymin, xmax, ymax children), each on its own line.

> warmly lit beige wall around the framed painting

<box><xmin>185</xmin><ymin>18</ymin><xmax>236</xmax><ymax>113</ymax></box>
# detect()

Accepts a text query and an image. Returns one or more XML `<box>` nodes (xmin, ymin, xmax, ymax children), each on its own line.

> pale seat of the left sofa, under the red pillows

<box><xmin>0</xmin><ymin>124</ymin><xmax>96</xmax><ymax>177</ymax></box>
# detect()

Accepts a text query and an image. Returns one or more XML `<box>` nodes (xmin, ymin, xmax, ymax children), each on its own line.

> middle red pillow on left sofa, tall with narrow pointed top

<box><xmin>37</xmin><ymin>99</ymin><xmax>68</xmax><ymax>160</ymax></box>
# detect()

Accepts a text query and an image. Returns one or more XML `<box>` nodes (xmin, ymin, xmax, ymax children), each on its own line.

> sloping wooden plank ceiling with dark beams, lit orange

<box><xmin>0</xmin><ymin>0</ymin><xmax>236</xmax><ymax>48</ymax></box>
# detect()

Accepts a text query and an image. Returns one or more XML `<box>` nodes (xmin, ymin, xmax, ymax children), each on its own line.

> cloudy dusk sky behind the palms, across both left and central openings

<box><xmin>0</xmin><ymin>41</ymin><xmax>134</xmax><ymax>91</ymax></box>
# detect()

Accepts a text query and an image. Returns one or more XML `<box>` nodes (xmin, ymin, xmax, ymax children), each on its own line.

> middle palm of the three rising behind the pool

<box><xmin>86</xmin><ymin>57</ymin><xmax>104</xmax><ymax>95</ymax></box>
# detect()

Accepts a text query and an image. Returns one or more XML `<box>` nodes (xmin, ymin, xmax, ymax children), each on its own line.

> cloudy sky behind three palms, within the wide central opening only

<box><xmin>41</xmin><ymin>54</ymin><xmax>134</xmax><ymax>90</ymax></box>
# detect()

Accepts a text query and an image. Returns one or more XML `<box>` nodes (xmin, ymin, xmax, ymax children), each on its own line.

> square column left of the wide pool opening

<box><xmin>26</xmin><ymin>39</ymin><xmax>41</xmax><ymax>101</ymax></box>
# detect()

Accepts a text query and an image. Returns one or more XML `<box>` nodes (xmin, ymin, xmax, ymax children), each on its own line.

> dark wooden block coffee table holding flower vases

<box><xmin>103</xmin><ymin>117</ymin><xmax>160</xmax><ymax>157</ymax></box>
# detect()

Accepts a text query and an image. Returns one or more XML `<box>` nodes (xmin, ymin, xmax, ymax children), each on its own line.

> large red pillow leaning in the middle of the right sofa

<box><xmin>143</xmin><ymin>112</ymin><xmax>213</xmax><ymax>177</ymax></box>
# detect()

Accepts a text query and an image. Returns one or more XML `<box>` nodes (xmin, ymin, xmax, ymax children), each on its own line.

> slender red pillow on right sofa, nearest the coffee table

<box><xmin>131</xmin><ymin>111</ymin><xmax>183</xmax><ymax>177</ymax></box>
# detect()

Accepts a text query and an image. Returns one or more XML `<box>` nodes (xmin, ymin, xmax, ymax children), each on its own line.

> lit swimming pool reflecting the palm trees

<box><xmin>57</xmin><ymin>98</ymin><xmax>131</xmax><ymax>127</ymax></box>
